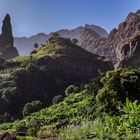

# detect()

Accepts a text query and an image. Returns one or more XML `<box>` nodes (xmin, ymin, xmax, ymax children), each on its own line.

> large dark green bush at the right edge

<box><xmin>96</xmin><ymin>68</ymin><xmax>140</xmax><ymax>109</ymax></box>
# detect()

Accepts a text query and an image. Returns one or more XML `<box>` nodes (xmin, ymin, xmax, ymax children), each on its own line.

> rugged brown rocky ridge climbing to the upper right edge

<box><xmin>81</xmin><ymin>10</ymin><xmax>140</xmax><ymax>64</ymax></box>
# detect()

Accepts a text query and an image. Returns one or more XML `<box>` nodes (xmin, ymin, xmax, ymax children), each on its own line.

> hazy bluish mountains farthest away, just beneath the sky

<box><xmin>14</xmin><ymin>24</ymin><xmax>108</xmax><ymax>55</ymax></box>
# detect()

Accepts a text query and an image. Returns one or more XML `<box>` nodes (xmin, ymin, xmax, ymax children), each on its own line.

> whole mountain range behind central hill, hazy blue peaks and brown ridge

<box><xmin>14</xmin><ymin>10</ymin><xmax>140</xmax><ymax>65</ymax></box>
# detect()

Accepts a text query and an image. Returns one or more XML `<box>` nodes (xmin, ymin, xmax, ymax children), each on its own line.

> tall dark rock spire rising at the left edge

<box><xmin>0</xmin><ymin>14</ymin><xmax>18</xmax><ymax>59</ymax></box>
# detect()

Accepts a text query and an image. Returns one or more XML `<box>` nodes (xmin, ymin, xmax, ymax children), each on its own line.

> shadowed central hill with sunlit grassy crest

<box><xmin>0</xmin><ymin>35</ymin><xmax>113</xmax><ymax>117</ymax></box>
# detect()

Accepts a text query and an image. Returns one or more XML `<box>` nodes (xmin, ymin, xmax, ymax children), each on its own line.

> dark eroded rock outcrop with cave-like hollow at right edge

<box><xmin>116</xmin><ymin>35</ymin><xmax>140</xmax><ymax>68</ymax></box>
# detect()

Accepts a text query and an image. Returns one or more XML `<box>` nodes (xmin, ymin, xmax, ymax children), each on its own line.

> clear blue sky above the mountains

<box><xmin>0</xmin><ymin>0</ymin><xmax>140</xmax><ymax>36</ymax></box>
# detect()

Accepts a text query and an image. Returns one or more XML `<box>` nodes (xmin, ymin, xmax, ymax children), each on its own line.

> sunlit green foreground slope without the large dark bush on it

<box><xmin>0</xmin><ymin>69</ymin><xmax>140</xmax><ymax>140</ymax></box>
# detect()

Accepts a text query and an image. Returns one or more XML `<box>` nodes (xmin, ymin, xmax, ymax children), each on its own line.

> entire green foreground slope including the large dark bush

<box><xmin>0</xmin><ymin>68</ymin><xmax>140</xmax><ymax>140</ymax></box>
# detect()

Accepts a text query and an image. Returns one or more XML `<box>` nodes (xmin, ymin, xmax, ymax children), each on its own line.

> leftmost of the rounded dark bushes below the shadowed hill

<box><xmin>22</xmin><ymin>101</ymin><xmax>42</xmax><ymax>116</ymax></box>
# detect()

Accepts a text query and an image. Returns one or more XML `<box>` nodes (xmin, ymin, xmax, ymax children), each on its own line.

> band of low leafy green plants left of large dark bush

<box><xmin>0</xmin><ymin>93</ymin><xmax>93</xmax><ymax>129</ymax></box>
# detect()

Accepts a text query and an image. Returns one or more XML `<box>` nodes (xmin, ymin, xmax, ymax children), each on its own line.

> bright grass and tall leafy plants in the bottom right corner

<box><xmin>59</xmin><ymin>99</ymin><xmax>140</xmax><ymax>140</ymax></box>
